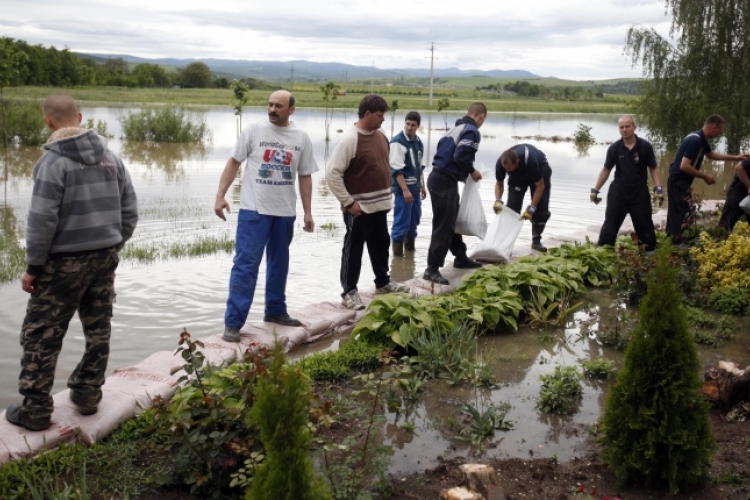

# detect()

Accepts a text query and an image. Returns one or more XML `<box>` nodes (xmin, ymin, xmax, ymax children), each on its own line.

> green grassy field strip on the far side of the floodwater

<box><xmin>4</xmin><ymin>85</ymin><xmax>636</xmax><ymax>113</ymax></box>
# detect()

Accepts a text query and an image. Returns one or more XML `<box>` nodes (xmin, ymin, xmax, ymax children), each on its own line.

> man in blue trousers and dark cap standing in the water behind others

<box><xmin>390</xmin><ymin>111</ymin><xmax>427</xmax><ymax>257</ymax></box>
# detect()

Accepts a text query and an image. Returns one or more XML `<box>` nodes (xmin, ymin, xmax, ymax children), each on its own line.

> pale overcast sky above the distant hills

<box><xmin>0</xmin><ymin>0</ymin><xmax>670</xmax><ymax>80</ymax></box>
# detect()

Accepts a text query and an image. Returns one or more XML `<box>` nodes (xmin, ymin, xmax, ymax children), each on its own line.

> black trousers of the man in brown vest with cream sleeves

<box><xmin>341</xmin><ymin>210</ymin><xmax>391</xmax><ymax>297</ymax></box>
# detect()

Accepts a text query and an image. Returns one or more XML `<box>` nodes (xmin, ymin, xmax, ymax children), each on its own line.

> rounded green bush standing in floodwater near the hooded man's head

<box><xmin>120</xmin><ymin>106</ymin><xmax>210</xmax><ymax>142</ymax></box>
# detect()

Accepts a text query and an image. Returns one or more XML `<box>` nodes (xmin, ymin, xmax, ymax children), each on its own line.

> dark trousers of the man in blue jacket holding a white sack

<box><xmin>427</xmin><ymin>170</ymin><xmax>466</xmax><ymax>269</ymax></box>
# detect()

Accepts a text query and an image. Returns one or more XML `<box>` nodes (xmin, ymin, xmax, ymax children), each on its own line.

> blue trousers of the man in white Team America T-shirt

<box><xmin>224</xmin><ymin>210</ymin><xmax>296</xmax><ymax>328</ymax></box>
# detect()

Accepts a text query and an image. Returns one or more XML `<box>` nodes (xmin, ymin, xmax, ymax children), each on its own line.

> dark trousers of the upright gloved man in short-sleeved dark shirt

<box><xmin>598</xmin><ymin>180</ymin><xmax>656</xmax><ymax>252</ymax></box>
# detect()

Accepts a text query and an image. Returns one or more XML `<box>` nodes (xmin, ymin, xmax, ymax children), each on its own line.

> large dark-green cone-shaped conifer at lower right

<box><xmin>601</xmin><ymin>242</ymin><xmax>715</xmax><ymax>494</ymax></box>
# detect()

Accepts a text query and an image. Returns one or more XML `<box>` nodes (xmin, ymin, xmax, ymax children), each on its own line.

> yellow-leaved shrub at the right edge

<box><xmin>690</xmin><ymin>221</ymin><xmax>750</xmax><ymax>290</ymax></box>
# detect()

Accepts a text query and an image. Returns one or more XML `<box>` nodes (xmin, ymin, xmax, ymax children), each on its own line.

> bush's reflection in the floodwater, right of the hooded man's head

<box><xmin>120</xmin><ymin>141</ymin><xmax>211</xmax><ymax>182</ymax></box>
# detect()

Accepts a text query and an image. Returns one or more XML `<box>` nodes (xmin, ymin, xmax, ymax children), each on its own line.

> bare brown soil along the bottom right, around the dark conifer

<box><xmin>390</xmin><ymin>412</ymin><xmax>750</xmax><ymax>500</ymax></box>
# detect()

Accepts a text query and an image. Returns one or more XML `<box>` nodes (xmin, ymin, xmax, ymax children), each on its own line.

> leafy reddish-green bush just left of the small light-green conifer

<box><xmin>154</xmin><ymin>331</ymin><xmax>266</xmax><ymax>498</ymax></box>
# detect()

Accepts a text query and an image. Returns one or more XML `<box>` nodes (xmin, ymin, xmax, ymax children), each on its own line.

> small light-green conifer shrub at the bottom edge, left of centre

<box><xmin>245</xmin><ymin>345</ymin><xmax>331</xmax><ymax>500</ymax></box>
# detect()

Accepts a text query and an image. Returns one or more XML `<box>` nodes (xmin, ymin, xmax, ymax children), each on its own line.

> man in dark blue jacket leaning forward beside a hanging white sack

<box><xmin>423</xmin><ymin>102</ymin><xmax>487</xmax><ymax>285</ymax></box>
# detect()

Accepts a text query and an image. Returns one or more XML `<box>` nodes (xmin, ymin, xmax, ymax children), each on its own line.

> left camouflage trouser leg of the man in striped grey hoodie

<box><xmin>18</xmin><ymin>255</ymin><xmax>99</xmax><ymax>419</ymax></box>
